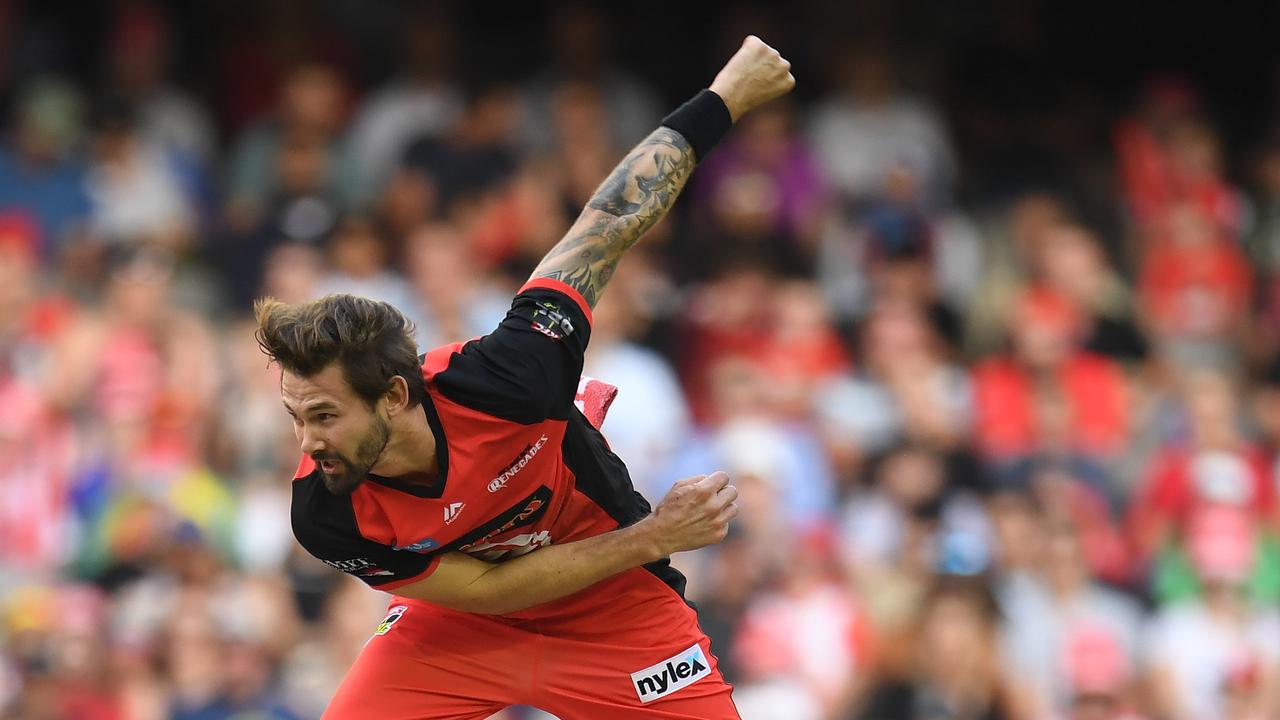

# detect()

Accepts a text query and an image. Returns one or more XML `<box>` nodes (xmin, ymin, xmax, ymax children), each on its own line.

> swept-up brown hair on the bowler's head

<box><xmin>253</xmin><ymin>289</ymin><xmax>426</xmax><ymax>407</ymax></box>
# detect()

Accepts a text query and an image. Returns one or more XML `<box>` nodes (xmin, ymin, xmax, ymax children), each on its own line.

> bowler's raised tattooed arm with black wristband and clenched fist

<box><xmin>532</xmin><ymin>35</ymin><xmax>795</xmax><ymax>307</ymax></box>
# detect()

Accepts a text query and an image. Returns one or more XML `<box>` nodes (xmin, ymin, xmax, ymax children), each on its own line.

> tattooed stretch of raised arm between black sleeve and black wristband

<box><xmin>534</xmin><ymin>127</ymin><xmax>696</xmax><ymax>307</ymax></box>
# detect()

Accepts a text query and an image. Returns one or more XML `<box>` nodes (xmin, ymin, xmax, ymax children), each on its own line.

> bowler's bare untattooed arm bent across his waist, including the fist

<box><xmin>396</xmin><ymin>473</ymin><xmax>737</xmax><ymax>615</ymax></box>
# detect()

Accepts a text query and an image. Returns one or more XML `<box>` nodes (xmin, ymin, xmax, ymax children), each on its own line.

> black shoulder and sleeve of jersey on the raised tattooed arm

<box><xmin>434</xmin><ymin>288</ymin><xmax>591</xmax><ymax>425</ymax></box>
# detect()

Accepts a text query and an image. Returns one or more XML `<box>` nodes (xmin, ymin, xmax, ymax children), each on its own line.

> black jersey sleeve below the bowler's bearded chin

<box><xmin>289</xmin><ymin>470</ymin><xmax>431</xmax><ymax>588</ymax></box>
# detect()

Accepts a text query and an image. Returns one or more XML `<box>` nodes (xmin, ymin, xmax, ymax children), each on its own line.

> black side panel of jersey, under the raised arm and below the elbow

<box><xmin>563</xmin><ymin>409</ymin><xmax>692</xmax><ymax>597</ymax></box>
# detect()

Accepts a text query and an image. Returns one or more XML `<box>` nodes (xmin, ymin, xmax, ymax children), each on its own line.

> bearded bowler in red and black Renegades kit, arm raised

<box><xmin>255</xmin><ymin>36</ymin><xmax>795</xmax><ymax>720</ymax></box>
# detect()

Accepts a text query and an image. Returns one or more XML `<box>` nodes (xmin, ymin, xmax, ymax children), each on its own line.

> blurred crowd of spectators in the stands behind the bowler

<box><xmin>0</xmin><ymin>0</ymin><xmax>1280</xmax><ymax>720</ymax></box>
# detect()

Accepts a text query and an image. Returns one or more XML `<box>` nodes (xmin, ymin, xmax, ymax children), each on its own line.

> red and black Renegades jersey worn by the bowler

<box><xmin>292</xmin><ymin>279</ymin><xmax>685</xmax><ymax>614</ymax></box>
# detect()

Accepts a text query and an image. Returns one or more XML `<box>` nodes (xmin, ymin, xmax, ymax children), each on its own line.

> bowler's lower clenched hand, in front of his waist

<box><xmin>637</xmin><ymin>470</ymin><xmax>737</xmax><ymax>556</ymax></box>
